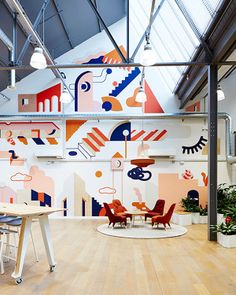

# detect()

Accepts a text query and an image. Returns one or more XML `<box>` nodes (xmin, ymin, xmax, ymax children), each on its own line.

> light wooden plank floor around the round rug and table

<box><xmin>0</xmin><ymin>219</ymin><xmax>236</xmax><ymax>295</ymax></box>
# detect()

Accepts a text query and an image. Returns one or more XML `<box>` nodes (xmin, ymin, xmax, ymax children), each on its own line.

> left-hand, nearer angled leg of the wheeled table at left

<box><xmin>11</xmin><ymin>216</ymin><xmax>32</xmax><ymax>283</ymax></box>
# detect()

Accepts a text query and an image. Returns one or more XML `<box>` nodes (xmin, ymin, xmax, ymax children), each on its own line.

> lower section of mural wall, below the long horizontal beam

<box><xmin>0</xmin><ymin>119</ymin><xmax>229</xmax><ymax>216</ymax></box>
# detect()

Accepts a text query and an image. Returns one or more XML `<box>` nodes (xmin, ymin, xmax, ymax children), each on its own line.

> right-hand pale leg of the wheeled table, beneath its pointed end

<box><xmin>39</xmin><ymin>215</ymin><xmax>56</xmax><ymax>272</ymax></box>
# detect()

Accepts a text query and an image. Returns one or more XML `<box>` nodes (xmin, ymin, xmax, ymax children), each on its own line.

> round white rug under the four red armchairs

<box><xmin>97</xmin><ymin>223</ymin><xmax>187</xmax><ymax>239</ymax></box>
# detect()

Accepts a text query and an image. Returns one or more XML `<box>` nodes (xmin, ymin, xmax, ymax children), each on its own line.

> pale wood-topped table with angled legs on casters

<box><xmin>0</xmin><ymin>203</ymin><xmax>64</xmax><ymax>284</ymax></box>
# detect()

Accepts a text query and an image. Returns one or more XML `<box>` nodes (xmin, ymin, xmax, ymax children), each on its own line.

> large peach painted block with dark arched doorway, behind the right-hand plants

<box><xmin>158</xmin><ymin>173</ymin><xmax>207</xmax><ymax>210</ymax></box>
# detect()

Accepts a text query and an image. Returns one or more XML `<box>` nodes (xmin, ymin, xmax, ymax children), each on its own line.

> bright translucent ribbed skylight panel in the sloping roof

<box><xmin>129</xmin><ymin>0</ymin><xmax>223</xmax><ymax>91</ymax></box>
